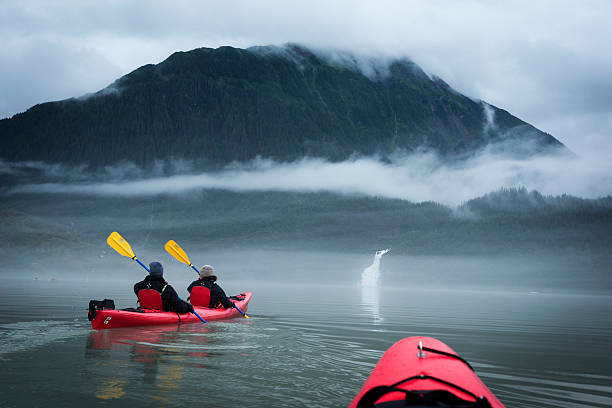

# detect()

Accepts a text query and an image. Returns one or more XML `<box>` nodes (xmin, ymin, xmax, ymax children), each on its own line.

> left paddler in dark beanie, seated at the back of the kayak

<box><xmin>134</xmin><ymin>262</ymin><xmax>193</xmax><ymax>314</ymax></box>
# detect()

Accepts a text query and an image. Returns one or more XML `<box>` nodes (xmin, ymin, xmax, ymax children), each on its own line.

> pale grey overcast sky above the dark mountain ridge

<box><xmin>0</xmin><ymin>0</ymin><xmax>612</xmax><ymax>152</ymax></box>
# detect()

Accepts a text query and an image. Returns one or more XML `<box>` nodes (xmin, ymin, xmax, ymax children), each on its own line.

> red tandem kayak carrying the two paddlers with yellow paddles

<box><xmin>90</xmin><ymin>292</ymin><xmax>252</xmax><ymax>330</ymax></box>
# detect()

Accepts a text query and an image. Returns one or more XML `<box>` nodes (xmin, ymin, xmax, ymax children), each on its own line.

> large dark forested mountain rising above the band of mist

<box><xmin>0</xmin><ymin>45</ymin><xmax>563</xmax><ymax>166</ymax></box>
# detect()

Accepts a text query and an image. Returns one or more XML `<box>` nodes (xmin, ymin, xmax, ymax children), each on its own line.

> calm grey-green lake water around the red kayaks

<box><xmin>0</xmin><ymin>254</ymin><xmax>612</xmax><ymax>407</ymax></box>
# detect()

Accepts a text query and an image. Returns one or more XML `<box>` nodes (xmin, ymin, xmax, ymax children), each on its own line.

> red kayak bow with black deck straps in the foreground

<box><xmin>349</xmin><ymin>337</ymin><xmax>504</xmax><ymax>408</ymax></box>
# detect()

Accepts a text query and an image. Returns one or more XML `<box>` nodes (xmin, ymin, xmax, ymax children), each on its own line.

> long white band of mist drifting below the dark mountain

<box><xmin>9</xmin><ymin>144</ymin><xmax>612</xmax><ymax>206</ymax></box>
